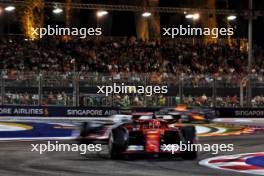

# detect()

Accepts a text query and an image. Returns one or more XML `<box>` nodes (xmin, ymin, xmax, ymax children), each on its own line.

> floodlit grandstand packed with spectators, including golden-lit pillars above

<box><xmin>0</xmin><ymin>0</ymin><xmax>264</xmax><ymax>107</ymax></box>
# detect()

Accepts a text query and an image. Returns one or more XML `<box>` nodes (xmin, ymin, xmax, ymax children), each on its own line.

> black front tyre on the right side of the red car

<box><xmin>182</xmin><ymin>126</ymin><xmax>198</xmax><ymax>160</ymax></box>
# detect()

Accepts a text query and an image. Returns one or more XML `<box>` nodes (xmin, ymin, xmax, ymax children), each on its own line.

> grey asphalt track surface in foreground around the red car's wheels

<box><xmin>0</xmin><ymin>134</ymin><xmax>264</xmax><ymax>176</ymax></box>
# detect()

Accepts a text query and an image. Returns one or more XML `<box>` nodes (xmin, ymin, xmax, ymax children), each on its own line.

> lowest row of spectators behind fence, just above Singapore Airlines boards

<box><xmin>3</xmin><ymin>92</ymin><xmax>264</xmax><ymax>108</ymax></box>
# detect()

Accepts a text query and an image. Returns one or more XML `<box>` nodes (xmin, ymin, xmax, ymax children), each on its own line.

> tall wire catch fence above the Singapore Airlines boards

<box><xmin>0</xmin><ymin>71</ymin><xmax>264</xmax><ymax>107</ymax></box>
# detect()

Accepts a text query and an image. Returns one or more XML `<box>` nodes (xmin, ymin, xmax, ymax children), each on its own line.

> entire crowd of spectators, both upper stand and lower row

<box><xmin>0</xmin><ymin>38</ymin><xmax>264</xmax><ymax>106</ymax></box>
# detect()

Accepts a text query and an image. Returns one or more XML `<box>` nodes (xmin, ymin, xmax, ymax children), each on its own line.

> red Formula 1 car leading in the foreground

<box><xmin>108</xmin><ymin>118</ymin><xmax>197</xmax><ymax>160</ymax></box>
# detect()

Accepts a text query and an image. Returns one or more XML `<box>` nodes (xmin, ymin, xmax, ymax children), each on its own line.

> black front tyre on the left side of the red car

<box><xmin>108</xmin><ymin>127</ymin><xmax>128</xmax><ymax>159</ymax></box>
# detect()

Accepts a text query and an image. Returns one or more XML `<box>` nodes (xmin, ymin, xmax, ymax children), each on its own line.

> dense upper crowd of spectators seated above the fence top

<box><xmin>0</xmin><ymin>38</ymin><xmax>264</xmax><ymax>75</ymax></box>
